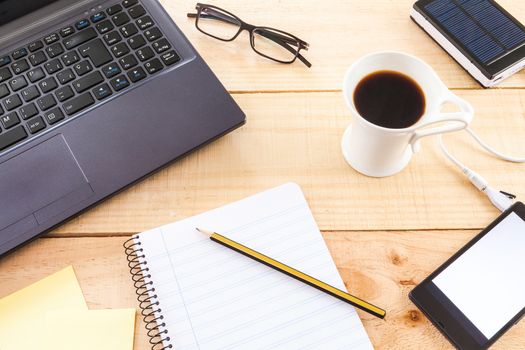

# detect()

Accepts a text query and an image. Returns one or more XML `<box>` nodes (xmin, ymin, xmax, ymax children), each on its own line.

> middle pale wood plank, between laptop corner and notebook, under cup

<box><xmin>54</xmin><ymin>90</ymin><xmax>525</xmax><ymax>235</ymax></box>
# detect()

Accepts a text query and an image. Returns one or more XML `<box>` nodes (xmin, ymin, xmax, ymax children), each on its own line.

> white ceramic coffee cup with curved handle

<box><xmin>342</xmin><ymin>52</ymin><xmax>474</xmax><ymax>177</ymax></box>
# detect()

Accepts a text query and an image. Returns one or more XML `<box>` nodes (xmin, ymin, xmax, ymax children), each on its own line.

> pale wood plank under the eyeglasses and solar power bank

<box><xmin>161</xmin><ymin>0</ymin><xmax>525</xmax><ymax>91</ymax></box>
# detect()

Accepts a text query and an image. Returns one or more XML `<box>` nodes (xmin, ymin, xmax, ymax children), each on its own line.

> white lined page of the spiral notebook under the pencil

<box><xmin>139</xmin><ymin>183</ymin><xmax>372</xmax><ymax>350</ymax></box>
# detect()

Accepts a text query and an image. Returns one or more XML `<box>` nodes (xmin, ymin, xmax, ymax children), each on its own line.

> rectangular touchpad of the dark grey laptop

<box><xmin>0</xmin><ymin>134</ymin><xmax>94</xmax><ymax>245</ymax></box>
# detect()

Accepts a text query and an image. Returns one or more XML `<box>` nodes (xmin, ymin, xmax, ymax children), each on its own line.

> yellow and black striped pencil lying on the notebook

<box><xmin>197</xmin><ymin>228</ymin><xmax>386</xmax><ymax>318</ymax></box>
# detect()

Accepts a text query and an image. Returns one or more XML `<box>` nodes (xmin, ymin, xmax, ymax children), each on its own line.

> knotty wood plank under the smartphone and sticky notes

<box><xmin>0</xmin><ymin>231</ymin><xmax>525</xmax><ymax>350</ymax></box>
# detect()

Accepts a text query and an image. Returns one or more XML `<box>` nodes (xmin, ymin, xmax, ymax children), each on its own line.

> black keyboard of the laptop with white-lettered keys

<box><xmin>0</xmin><ymin>0</ymin><xmax>180</xmax><ymax>151</ymax></box>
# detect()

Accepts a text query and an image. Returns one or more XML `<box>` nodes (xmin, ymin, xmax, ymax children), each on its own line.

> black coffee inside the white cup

<box><xmin>354</xmin><ymin>70</ymin><xmax>425</xmax><ymax>129</ymax></box>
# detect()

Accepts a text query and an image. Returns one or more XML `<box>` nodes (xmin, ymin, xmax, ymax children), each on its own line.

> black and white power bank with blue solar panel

<box><xmin>410</xmin><ymin>0</ymin><xmax>525</xmax><ymax>87</ymax></box>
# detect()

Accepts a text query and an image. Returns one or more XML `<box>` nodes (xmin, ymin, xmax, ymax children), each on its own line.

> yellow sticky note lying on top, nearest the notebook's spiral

<box><xmin>44</xmin><ymin>309</ymin><xmax>135</xmax><ymax>350</ymax></box>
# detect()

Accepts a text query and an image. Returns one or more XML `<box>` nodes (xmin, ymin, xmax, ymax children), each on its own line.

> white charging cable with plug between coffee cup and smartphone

<box><xmin>438</xmin><ymin>128</ymin><xmax>525</xmax><ymax>211</ymax></box>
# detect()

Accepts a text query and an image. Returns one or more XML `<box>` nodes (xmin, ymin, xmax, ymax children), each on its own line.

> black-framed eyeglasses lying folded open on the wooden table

<box><xmin>188</xmin><ymin>3</ymin><xmax>312</xmax><ymax>68</ymax></box>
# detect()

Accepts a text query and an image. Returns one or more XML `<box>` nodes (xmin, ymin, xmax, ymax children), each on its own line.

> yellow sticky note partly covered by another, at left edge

<box><xmin>0</xmin><ymin>266</ymin><xmax>87</xmax><ymax>350</ymax></box>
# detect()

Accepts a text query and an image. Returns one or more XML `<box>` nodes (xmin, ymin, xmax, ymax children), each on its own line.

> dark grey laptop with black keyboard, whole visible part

<box><xmin>0</xmin><ymin>0</ymin><xmax>245</xmax><ymax>255</ymax></box>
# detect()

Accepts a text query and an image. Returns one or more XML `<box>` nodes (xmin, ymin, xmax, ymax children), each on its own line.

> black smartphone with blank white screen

<box><xmin>409</xmin><ymin>202</ymin><xmax>525</xmax><ymax>350</ymax></box>
